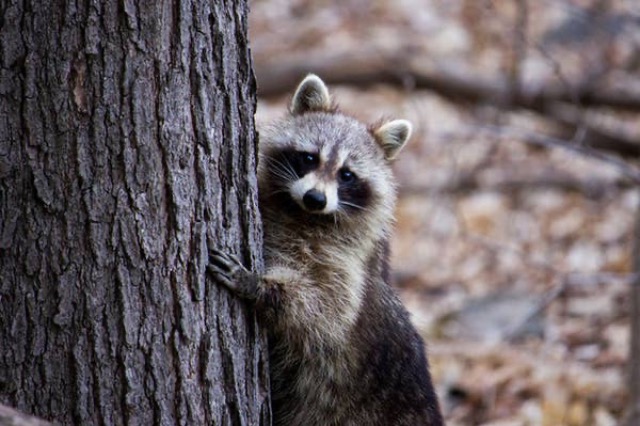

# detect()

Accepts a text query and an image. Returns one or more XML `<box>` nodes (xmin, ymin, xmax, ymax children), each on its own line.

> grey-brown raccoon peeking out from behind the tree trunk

<box><xmin>208</xmin><ymin>75</ymin><xmax>443</xmax><ymax>426</ymax></box>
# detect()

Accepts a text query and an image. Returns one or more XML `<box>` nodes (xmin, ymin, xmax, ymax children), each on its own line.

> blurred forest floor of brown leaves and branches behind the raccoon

<box><xmin>250</xmin><ymin>0</ymin><xmax>640</xmax><ymax>426</ymax></box>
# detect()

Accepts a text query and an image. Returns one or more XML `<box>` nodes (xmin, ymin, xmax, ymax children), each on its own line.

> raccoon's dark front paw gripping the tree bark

<box><xmin>207</xmin><ymin>249</ymin><xmax>258</xmax><ymax>298</ymax></box>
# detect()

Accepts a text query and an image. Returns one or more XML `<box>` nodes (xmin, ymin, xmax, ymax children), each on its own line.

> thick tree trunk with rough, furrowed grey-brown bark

<box><xmin>0</xmin><ymin>0</ymin><xmax>270</xmax><ymax>425</ymax></box>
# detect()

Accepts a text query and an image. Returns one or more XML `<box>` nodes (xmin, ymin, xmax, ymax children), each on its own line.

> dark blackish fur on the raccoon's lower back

<box><xmin>354</xmin><ymin>282</ymin><xmax>443</xmax><ymax>426</ymax></box>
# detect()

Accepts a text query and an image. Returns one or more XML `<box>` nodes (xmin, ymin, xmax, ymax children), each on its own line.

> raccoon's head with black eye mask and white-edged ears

<box><xmin>259</xmin><ymin>75</ymin><xmax>411</xmax><ymax>230</ymax></box>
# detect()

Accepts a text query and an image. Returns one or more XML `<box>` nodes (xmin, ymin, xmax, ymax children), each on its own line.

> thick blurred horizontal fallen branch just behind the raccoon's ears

<box><xmin>255</xmin><ymin>46</ymin><xmax>640</xmax><ymax>112</ymax></box>
